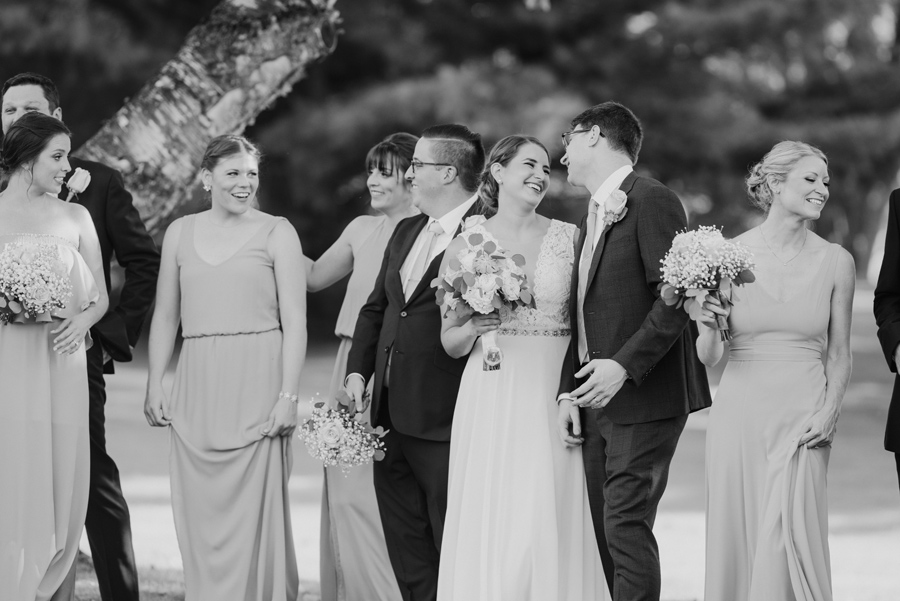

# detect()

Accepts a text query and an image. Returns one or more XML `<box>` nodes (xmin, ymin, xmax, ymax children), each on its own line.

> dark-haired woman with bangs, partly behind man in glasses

<box><xmin>306</xmin><ymin>133</ymin><xmax>418</xmax><ymax>601</ymax></box>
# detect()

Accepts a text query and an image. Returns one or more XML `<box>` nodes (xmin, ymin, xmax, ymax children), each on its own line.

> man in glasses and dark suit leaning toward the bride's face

<box><xmin>557</xmin><ymin>102</ymin><xmax>711</xmax><ymax>601</ymax></box>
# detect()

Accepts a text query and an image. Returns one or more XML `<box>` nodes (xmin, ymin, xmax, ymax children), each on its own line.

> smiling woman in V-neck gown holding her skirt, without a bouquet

<box><xmin>144</xmin><ymin>135</ymin><xmax>306</xmax><ymax>601</ymax></box>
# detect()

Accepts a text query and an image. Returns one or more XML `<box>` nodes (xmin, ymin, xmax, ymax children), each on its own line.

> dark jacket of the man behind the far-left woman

<box><xmin>60</xmin><ymin>157</ymin><xmax>159</xmax><ymax>373</ymax></box>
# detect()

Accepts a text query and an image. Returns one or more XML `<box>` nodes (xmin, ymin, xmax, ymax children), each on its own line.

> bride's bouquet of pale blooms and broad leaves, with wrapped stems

<box><xmin>431</xmin><ymin>232</ymin><xmax>534</xmax><ymax>371</ymax></box>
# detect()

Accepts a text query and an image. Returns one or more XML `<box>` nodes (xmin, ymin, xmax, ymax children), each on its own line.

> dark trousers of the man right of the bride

<box><xmin>581</xmin><ymin>400</ymin><xmax>687</xmax><ymax>601</ymax></box>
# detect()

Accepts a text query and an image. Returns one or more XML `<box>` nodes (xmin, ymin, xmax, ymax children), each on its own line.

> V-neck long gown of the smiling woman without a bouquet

<box><xmin>169</xmin><ymin>216</ymin><xmax>299</xmax><ymax>601</ymax></box>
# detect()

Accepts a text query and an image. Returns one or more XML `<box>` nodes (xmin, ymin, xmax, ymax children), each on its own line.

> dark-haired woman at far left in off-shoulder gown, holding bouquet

<box><xmin>0</xmin><ymin>113</ymin><xmax>109</xmax><ymax>601</ymax></box>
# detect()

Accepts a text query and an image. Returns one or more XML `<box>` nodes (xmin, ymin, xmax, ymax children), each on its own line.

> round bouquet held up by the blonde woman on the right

<box><xmin>659</xmin><ymin>225</ymin><xmax>756</xmax><ymax>341</ymax></box>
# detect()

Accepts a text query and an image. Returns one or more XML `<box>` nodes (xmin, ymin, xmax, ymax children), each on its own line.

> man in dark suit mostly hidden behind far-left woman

<box><xmin>0</xmin><ymin>73</ymin><xmax>159</xmax><ymax>601</ymax></box>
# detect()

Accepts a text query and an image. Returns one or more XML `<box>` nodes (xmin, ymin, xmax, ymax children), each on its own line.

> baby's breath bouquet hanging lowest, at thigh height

<box><xmin>297</xmin><ymin>391</ymin><xmax>387</xmax><ymax>475</ymax></box>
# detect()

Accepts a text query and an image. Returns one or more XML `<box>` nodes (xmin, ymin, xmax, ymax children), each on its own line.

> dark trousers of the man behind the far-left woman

<box><xmin>84</xmin><ymin>342</ymin><xmax>139</xmax><ymax>601</ymax></box>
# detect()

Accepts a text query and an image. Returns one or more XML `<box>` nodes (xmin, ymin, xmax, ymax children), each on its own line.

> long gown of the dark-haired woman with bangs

<box><xmin>320</xmin><ymin>217</ymin><xmax>401</xmax><ymax>601</ymax></box>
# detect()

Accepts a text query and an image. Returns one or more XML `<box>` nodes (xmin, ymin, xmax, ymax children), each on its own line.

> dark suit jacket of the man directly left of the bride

<box><xmin>347</xmin><ymin>202</ymin><xmax>480</xmax><ymax>441</ymax></box>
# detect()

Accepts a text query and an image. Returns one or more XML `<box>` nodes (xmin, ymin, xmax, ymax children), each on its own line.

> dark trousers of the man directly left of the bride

<box><xmin>374</xmin><ymin>388</ymin><xmax>450</xmax><ymax>601</ymax></box>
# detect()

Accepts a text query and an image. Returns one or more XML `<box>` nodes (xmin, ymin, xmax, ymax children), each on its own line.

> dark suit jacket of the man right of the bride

<box><xmin>560</xmin><ymin>172</ymin><xmax>712</xmax><ymax>424</ymax></box>
